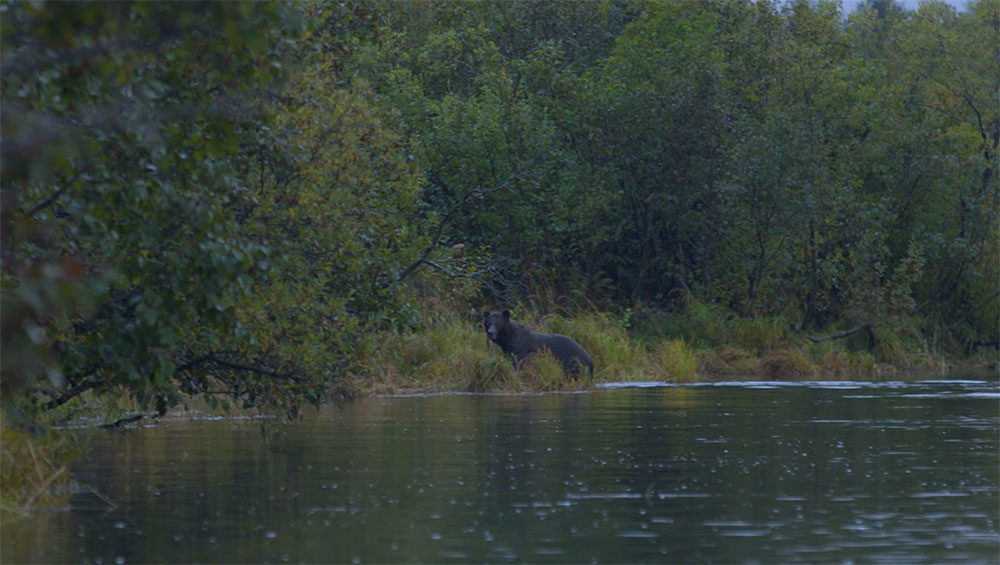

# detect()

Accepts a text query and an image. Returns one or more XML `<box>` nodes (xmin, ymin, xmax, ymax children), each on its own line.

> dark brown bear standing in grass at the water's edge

<box><xmin>483</xmin><ymin>310</ymin><xmax>594</xmax><ymax>377</ymax></box>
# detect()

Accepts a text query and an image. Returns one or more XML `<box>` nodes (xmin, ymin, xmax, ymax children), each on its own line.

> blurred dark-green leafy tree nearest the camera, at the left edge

<box><xmin>3</xmin><ymin>3</ymin><xmax>301</xmax><ymax>418</ymax></box>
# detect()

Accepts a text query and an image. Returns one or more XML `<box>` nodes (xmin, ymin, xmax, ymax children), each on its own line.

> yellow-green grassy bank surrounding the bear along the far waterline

<box><xmin>362</xmin><ymin>303</ymin><xmax>996</xmax><ymax>394</ymax></box>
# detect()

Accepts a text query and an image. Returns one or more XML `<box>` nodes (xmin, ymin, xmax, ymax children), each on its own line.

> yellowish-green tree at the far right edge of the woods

<box><xmin>895</xmin><ymin>1</ymin><xmax>1000</xmax><ymax>348</ymax></box>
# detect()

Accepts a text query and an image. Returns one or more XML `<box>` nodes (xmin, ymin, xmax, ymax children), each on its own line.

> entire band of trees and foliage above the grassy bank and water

<box><xmin>0</xmin><ymin>0</ymin><xmax>1000</xmax><ymax>424</ymax></box>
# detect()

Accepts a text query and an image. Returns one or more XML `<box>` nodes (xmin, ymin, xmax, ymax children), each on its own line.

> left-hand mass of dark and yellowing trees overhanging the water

<box><xmin>2</xmin><ymin>3</ymin><xmax>436</xmax><ymax>415</ymax></box>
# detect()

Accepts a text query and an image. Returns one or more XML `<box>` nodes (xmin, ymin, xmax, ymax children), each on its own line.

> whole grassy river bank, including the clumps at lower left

<box><xmin>0</xmin><ymin>303</ymin><xmax>997</xmax><ymax>519</ymax></box>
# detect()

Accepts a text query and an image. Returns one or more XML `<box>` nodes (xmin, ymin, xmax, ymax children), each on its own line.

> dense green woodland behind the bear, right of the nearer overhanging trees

<box><xmin>360</xmin><ymin>1</ymin><xmax>1000</xmax><ymax>353</ymax></box>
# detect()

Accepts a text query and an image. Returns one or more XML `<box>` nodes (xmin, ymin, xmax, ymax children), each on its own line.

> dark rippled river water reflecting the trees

<box><xmin>0</xmin><ymin>381</ymin><xmax>1000</xmax><ymax>563</ymax></box>
